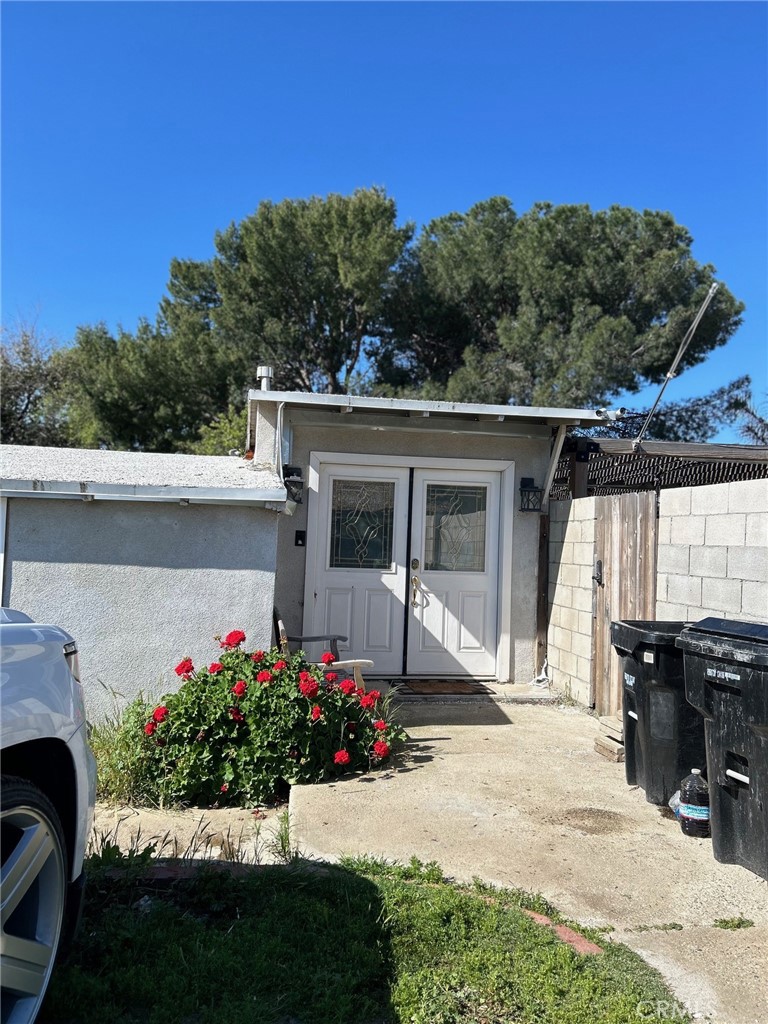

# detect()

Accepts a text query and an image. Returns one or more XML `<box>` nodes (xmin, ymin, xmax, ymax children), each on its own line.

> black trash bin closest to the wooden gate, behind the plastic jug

<box><xmin>610</xmin><ymin>621</ymin><xmax>706</xmax><ymax>804</ymax></box>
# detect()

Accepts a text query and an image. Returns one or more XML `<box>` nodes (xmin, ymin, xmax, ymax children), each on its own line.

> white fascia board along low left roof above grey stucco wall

<box><xmin>0</xmin><ymin>480</ymin><xmax>288</xmax><ymax>508</ymax></box>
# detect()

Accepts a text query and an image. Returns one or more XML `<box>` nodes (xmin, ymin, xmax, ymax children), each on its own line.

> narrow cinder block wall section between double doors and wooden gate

<box><xmin>547</xmin><ymin>498</ymin><xmax>595</xmax><ymax>705</ymax></box>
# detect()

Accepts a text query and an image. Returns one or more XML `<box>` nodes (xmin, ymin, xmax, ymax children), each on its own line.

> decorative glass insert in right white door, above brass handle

<box><xmin>424</xmin><ymin>483</ymin><xmax>486</xmax><ymax>572</ymax></box>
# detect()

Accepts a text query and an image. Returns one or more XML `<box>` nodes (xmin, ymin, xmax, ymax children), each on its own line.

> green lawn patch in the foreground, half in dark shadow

<box><xmin>40</xmin><ymin>847</ymin><xmax>681</xmax><ymax>1024</ymax></box>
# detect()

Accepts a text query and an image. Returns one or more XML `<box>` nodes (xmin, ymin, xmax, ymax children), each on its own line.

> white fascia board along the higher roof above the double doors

<box><xmin>248</xmin><ymin>389</ymin><xmax>603</xmax><ymax>425</ymax></box>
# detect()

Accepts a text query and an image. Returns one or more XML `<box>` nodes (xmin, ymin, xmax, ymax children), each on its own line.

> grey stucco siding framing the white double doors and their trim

<box><xmin>275</xmin><ymin>424</ymin><xmax>550</xmax><ymax>683</ymax></box>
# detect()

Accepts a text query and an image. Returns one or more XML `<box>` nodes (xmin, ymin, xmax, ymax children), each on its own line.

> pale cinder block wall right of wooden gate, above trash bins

<box><xmin>656</xmin><ymin>479</ymin><xmax>768</xmax><ymax>623</ymax></box>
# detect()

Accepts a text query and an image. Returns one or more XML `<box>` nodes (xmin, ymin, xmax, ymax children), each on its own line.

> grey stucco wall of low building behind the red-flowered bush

<box><xmin>2</xmin><ymin>499</ymin><xmax>278</xmax><ymax>720</ymax></box>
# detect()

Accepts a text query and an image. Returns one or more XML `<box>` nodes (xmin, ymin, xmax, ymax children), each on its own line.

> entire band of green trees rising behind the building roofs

<box><xmin>2</xmin><ymin>188</ymin><xmax>750</xmax><ymax>452</ymax></box>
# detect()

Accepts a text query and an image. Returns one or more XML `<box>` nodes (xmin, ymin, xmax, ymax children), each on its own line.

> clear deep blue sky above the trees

<box><xmin>1</xmin><ymin>0</ymin><xmax>768</xmax><ymax>439</ymax></box>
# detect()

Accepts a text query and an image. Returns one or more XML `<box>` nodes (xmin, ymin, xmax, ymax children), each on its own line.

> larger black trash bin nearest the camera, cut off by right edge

<box><xmin>678</xmin><ymin>618</ymin><xmax>768</xmax><ymax>879</ymax></box>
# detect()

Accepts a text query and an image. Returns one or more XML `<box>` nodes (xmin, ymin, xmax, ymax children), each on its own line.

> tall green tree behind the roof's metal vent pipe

<box><xmin>161</xmin><ymin>188</ymin><xmax>412</xmax><ymax>393</ymax></box>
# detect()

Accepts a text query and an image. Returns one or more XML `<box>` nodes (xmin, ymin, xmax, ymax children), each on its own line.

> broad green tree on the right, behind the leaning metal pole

<box><xmin>380</xmin><ymin>198</ymin><xmax>743</xmax><ymax>407</ymax></box>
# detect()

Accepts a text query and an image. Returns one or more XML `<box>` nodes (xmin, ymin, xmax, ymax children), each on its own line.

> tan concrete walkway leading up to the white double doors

<box><xmin>290</xmin><ymin>698</ymin><xmax>768</xmax><ymax>1024</ymax></box>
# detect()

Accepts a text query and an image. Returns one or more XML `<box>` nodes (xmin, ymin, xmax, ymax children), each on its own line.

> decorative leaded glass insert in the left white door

<box><xmin>330</xmin><ymin>480</ymin><xmax>394</xmax><ymax>569</ymax></box>
